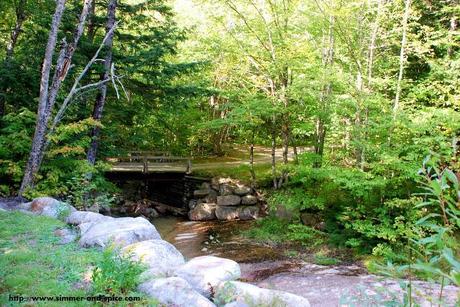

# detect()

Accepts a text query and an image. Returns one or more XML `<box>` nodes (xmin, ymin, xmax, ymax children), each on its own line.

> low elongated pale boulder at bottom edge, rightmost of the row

<box><xmin>216</xmin><ymin>281</ymin><xmax>310</xmax><ymax>307</ymax></box>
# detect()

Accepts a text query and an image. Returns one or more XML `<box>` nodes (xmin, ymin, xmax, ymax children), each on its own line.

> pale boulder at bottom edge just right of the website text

<box><xmin>138</xmin><ymin>277</ymin><xmax>215</xmax><ymax>307</ymax></box>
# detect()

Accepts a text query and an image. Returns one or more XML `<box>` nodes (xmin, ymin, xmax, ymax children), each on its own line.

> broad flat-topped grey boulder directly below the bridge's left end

<box><xmin>79</xmin><ymin>217</ymin><xmax>161</xmax><ymax>247</ymax></box>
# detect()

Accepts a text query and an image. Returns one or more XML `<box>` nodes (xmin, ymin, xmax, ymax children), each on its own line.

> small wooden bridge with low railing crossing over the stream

<box><xmin>106</xmin><ymin>151</ymin><xmax>192</xmax><ymax>174</ymax></box>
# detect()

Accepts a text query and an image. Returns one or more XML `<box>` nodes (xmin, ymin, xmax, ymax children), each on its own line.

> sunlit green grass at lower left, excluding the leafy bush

<box><xmin>0</xmin><ymin>212</ymin><xmax>151</xmax><ymax>306</ymax></box>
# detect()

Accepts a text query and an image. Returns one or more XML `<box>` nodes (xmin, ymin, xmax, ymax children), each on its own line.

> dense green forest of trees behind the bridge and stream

<box><xmin>0</xmin><ymin>0</ymin><xmax>460</xmax><ymax>274</ymax></box>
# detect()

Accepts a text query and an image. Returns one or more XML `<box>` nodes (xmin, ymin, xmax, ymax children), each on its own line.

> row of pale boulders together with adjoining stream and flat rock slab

<box><xmin>0</xmin><ymin>198</ymin><xmax>459</xmax><ymax>307</ymax></box>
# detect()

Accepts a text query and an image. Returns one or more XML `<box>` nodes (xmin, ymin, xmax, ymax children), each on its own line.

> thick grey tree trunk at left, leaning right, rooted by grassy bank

<box><xmin>19</xmin><ymin>0</ymin><xmax>66</xmax><ymax>195</ymax></box>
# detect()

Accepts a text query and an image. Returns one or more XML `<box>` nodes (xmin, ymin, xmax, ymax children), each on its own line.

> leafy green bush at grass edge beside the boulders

<box><xmin>92</xmin><ymin>248</ymin><xmax>145</xmax><ymax>296</ymax></box>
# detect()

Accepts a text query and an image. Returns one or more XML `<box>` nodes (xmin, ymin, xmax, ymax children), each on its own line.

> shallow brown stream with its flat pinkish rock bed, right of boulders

<box><xmin>151</xmin><ymin>216</ymin><xmax>459</xmax><ymax>307</ymax></box>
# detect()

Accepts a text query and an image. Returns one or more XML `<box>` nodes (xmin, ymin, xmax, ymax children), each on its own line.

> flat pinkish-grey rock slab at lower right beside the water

<box><xmin>256</xmin><ymin>264</ymin><xmax>460</xmax><ymax>307</ymax></box>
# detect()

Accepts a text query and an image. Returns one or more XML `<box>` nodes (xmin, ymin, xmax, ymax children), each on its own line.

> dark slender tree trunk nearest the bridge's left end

<box><xmin>87</xmin><ymin>0</ymin><xmax>117</xmax><ymax>165</ymax></box>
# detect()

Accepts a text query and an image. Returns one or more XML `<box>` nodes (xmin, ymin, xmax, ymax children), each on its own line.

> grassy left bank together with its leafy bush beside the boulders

<box><xmin>0</xmin><ymin>212</ymin><xmax>147</xmax><ymax>306</ymax></box>
